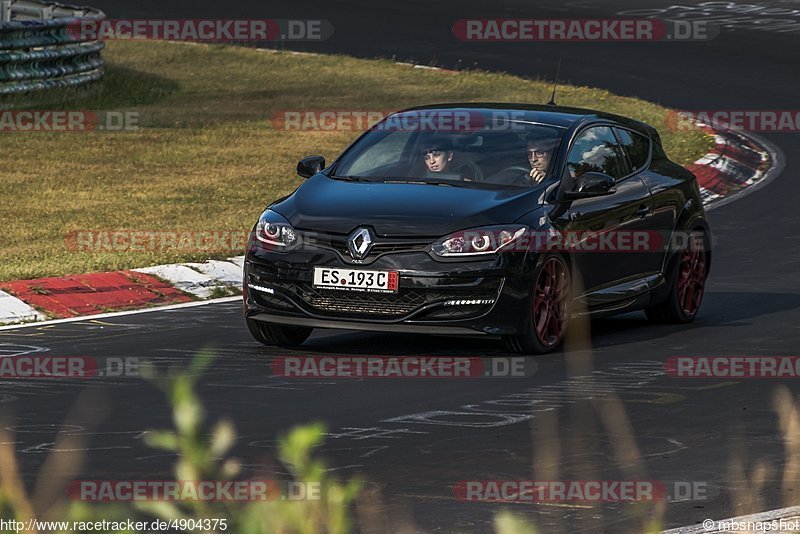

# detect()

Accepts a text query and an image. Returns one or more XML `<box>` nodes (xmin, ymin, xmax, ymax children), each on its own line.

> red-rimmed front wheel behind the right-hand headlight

<box><xmin>504</xmin><ymin>254</ymin><xmax>572</xmax><ymax>354</ymax></box>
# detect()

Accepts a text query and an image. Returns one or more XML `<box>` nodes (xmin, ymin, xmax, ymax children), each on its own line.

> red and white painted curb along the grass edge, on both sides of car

<box><xmin>0</xmin><ymin>125</ymin><xmax>782</xmax><ymax>325</ymax></box>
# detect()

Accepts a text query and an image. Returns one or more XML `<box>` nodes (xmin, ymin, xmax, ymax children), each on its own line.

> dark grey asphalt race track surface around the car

<box><xmin>0</xmin><ymin>0</ymin><xmax>800</xmax><ymax>532</ymax></box>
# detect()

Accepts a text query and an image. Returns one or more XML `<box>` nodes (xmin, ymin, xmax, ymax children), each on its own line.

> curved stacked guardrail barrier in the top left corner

<box><xmin>0</xmin><ymin>0</ymin><xmax>105</xmax><ymax>95</ymax></box>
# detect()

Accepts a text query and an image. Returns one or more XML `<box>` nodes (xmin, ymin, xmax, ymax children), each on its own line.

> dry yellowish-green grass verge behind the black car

<box><xmin>0</xmin><ymin>42</ymin><xmax>711</xmax><ymax>281</ymax></box>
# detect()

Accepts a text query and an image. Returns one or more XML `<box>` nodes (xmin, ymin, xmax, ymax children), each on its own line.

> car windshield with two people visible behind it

<box><xmin>333</xmin><ymin>111</ymin><xmax>565</xmax><ymax>187</ymax></box>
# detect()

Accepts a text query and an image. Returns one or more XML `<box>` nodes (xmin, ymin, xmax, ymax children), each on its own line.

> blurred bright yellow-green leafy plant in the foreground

<box><xmin>136</xmin><ymin>352</ymin><xmax>361</xmax><ymax>534</ymax></box>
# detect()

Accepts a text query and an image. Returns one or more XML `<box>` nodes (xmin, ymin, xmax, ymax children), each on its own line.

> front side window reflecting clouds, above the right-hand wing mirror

<box><xmin>567</xmin><ymin>126</ymin><xmax>630</xmax><ymax>180</ymax></box>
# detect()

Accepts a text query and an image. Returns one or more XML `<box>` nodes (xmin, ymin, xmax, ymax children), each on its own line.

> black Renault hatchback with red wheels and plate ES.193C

<box><xmin>244</xmin><ymin>104</ymin><xmax>711</xmax><ymax>353</ymax></box>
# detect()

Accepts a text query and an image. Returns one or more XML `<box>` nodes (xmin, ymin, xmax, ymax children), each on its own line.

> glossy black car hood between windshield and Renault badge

<box><xmin>271</xmin><ymin>174</ymin><xmax>542</xmax><ymax>236</ymax></box>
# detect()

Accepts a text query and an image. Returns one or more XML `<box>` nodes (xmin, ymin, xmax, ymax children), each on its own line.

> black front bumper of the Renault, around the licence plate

<box><xmin>243</xmin><ymin>238</ymin><xmax>533</xmax><ymax>335</ymax></box>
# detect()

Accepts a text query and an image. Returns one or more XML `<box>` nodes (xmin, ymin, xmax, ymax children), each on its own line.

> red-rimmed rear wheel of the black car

<box><xmin>645</xmin><ymin>232</ymin><xmax>710</xmax><ymax>324</ymax></box>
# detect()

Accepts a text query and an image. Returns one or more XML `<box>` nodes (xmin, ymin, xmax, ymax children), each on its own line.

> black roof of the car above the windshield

<box><xmin>398</xmin><ymin>102</ymin><xmax>658</xmax><ymax>138</ymax></box>
